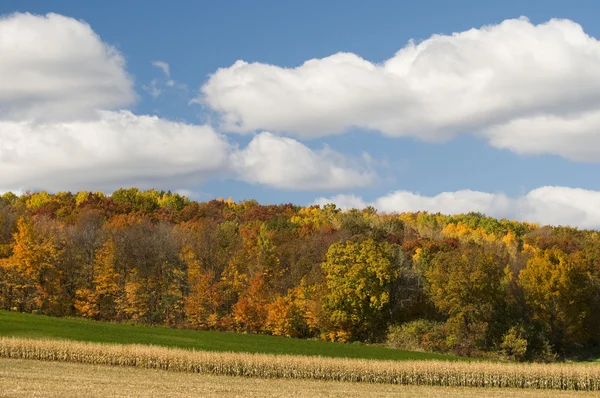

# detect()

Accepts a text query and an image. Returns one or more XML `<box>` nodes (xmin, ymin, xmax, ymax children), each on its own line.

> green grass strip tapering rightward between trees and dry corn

<box><xmin>0</xmin><ymin>311</ymin><xmax>466</xmax><ymax>361</ymax></box>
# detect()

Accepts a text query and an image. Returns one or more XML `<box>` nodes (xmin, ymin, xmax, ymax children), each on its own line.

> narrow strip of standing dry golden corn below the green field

<box><xmin>0</xmin><ymin>337</ymin><xmax>600</xmax><ymax>391</ymax></box>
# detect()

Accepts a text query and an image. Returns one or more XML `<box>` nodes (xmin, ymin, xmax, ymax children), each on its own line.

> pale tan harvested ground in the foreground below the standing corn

<box><xmin>0</xmin><ymin>358</ymin><xmax>598</xmax><ymax>398</ymax></box>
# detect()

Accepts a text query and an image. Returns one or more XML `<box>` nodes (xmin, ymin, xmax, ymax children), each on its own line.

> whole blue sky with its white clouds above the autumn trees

<box><xmin>0</xmin><ymin>0</ymin><xmax>600</xmax><ymax>229</ymax></box>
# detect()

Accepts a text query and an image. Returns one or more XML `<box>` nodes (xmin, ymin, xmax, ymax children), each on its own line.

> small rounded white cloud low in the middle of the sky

<box><xmin>233</xmin><ymin>133</ymin><xmax>375</xmax><ymax>190</ymax></box>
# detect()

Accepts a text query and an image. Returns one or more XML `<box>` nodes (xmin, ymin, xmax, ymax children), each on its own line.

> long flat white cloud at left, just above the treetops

<box><xmin>0</xmin><ymin>111</ymin><xmax>230</xmax><ymax>190</ymax></box>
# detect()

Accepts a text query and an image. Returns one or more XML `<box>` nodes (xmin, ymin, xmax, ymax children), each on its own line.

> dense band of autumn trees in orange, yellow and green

<box><xmin>0</xmin><ymin>188</ymin><xmax>600</xmax><ymax>360</ymax></box>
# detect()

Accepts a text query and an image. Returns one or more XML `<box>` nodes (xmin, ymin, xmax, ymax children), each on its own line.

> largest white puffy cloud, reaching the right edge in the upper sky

<box><xmin>202</xmin><ymin>18</ymin><xmax>600</xmax><ymax>160</ymax></box>
